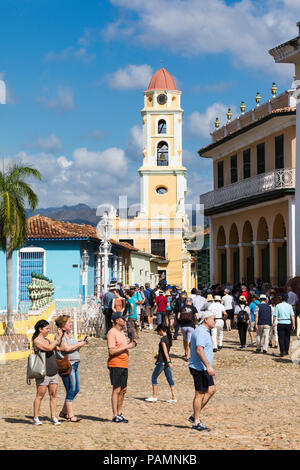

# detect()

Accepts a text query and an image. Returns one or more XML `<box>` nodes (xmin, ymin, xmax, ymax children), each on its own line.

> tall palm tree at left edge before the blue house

<box><xmin>0</xmin><ymin>162</ymin><xmax>42</xmax><ymax>334</ymax></box>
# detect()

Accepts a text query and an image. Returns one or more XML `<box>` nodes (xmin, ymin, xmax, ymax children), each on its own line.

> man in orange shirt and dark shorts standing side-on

<box><xmin>107</xmin><ymin>312</ymin><xmax>137</xmax><ymax>423</ymax></box>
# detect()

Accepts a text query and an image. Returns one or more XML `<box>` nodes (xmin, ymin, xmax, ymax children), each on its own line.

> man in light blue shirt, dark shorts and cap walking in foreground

<box><xmin>189</xmin><ymin>311</ymin><xmax>216</xmax><ymax>431</ymax></box>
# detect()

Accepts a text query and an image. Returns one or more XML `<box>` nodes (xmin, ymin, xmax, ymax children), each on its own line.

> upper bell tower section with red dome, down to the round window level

<box><xmin>139</xmin><ymin>68</ymin><xmax>186</xmax><ymax>218</ymax></box>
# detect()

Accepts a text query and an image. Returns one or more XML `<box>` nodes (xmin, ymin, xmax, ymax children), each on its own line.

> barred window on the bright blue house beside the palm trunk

<box><xmin>19</xmin><ymin>250</ymin><xmax>45</xmax><ymax>302</ymax></box>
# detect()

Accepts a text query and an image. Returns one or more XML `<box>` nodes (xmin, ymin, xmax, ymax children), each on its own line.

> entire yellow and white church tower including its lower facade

<box><xmin>110</xmin><ymin>68</ymin><xmax>190</xmax><ymax>290</ymax></box>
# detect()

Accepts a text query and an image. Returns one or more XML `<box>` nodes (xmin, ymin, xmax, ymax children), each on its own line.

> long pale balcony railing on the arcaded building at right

<box><xmin>200</xmin><ymin>168</ymin><xmax>296</xmax><ymax>209</ymax></box>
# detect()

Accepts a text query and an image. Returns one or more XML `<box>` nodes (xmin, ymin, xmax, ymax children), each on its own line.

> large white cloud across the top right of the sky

<box><xmin>104</xmin><ymin>0</ymin><xmax>300</xmax><ymax>75</ymax></box>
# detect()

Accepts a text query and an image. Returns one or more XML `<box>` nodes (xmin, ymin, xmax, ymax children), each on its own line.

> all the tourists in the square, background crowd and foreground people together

<box><xmin>28</xmin><ymin>282</ymin><xmax>300</xmax><ymax>431</ymax></box>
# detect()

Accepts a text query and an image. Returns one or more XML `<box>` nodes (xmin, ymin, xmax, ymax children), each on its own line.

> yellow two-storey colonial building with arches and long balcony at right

<box><xmin>198</xmin><ymin>88</ymin><xmax>296</xmax><ymax>286</ymax></box>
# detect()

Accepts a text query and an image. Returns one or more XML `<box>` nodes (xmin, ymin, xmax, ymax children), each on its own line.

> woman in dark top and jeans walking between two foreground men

<box><xmin>146</xmin><ymin>324</ymin><xmax>177</xmax><ymax>403</ymax></box>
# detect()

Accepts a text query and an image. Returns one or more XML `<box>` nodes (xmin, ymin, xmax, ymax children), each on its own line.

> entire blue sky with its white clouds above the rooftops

<box><xmin>0</xmin><ymin>0</ymin><xmax>300</xmax><ymax>207</ymax></box>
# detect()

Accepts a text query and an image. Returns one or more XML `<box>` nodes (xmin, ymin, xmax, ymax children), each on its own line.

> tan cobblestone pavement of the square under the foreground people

<box><xmin>0</xmin><ymin>330</ymin><xmax>300</xmax><ymax>450</ymax></box>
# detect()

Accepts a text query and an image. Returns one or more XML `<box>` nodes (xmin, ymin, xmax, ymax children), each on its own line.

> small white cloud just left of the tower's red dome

<box><xmin>107</xmin><ymin>64</ymin><xmax>153</xmax><ymax>90</ymax></box>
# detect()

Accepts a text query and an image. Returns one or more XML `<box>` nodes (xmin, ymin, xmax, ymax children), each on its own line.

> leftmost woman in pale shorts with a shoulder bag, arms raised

<box><xmin>32</xmin><ymin>320</ymin><xmax>63</xmax><ymax>426</ymax></box>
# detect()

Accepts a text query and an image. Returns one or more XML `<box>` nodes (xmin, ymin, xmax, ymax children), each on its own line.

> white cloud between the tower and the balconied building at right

<box><xmin>187</xmin><ymin>103</ymin><xmax>236</xmax><ymax>138</ymax></box>
